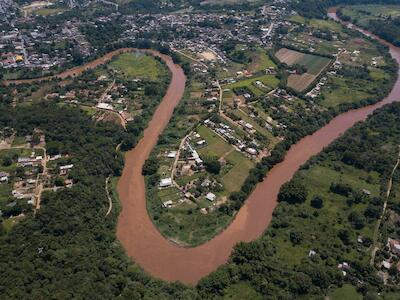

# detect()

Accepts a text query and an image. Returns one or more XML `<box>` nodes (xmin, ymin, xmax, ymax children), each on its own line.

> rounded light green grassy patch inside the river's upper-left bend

<box><xmin>110</xmin><ymin>52</ymin><xmax>161</xmax><ymax>80</ymax></box>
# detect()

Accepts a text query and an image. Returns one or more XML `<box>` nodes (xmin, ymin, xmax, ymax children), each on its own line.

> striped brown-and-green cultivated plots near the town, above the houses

<box><xmin>275</xmin><ymin>48</ymin><xmax>331</xmax><ymax>92</ymax></box>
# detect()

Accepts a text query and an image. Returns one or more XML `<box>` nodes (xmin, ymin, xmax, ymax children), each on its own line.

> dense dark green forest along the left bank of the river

<box><xmin>0</xmin><ymin>104</ymin><xmax>197</xmax><ymax>299</ymax></box>
